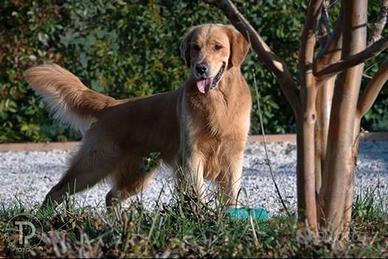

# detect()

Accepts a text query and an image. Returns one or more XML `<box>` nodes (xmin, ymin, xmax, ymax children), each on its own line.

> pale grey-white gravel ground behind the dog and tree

<box><xmin>0</xmin><ymin>141</ymin><xmax>388</xmax><ymax>214</ymax></box>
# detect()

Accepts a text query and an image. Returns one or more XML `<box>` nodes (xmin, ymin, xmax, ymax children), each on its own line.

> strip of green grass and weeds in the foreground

<box><xmin>0</xmin><ymin>190</ymin><xmax>388</xmax><ymax>257</ymax></box>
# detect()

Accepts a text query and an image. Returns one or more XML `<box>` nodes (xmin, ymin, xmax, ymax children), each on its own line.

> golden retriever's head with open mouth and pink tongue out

<box><xmin>180</xmin><ymin>24</ymin><xmax>249</xmax><ymax>93</ymax></box>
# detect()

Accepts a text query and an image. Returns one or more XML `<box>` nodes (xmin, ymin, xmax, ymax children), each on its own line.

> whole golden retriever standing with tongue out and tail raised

<box><xmin>25</xmin><ymin>24</ymin><xmax>251</xmax><ymax>207</ymax></box>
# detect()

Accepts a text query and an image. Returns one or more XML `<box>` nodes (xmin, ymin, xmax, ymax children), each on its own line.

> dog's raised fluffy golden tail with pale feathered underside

<box><xmin>24</xmin><ymin>64</ymin><xmax>119</xmax><ymax>135</ymax></box>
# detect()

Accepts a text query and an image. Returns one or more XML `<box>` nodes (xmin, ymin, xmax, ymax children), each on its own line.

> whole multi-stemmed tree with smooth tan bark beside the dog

<box><xmin>208</xmin><ymin>0</ymin><xmax>388</xmax><ymax>242</ymax></box>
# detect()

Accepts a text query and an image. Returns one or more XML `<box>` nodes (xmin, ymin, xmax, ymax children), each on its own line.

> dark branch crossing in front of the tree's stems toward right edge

<box><xmin>314</xmin><ymin>37</ymin><xmax>388</xmax><ymax>80</ymax></box>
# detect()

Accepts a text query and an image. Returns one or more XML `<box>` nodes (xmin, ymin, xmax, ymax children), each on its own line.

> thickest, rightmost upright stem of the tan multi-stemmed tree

<box><xmin>321</xmin><ymin>0</ymin><xmax>368</xmax><ymax>236</ymax></box>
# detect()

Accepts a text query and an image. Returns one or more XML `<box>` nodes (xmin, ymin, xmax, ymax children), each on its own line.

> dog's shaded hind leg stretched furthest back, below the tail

<box><xmin>42</xmin><ymin>144</ymin><xmax>118</xmax><ymax>207</ymax></box>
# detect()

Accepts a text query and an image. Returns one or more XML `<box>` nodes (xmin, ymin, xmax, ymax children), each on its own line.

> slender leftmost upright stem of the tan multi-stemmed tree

<box><xmin>297</xmin><ymin>0</ymin><xmax>323</xmax><ymax>231</ymax></box>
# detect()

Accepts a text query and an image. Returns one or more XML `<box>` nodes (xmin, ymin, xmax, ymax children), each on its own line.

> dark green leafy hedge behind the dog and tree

<box><xmin>0</xmin><ymin>0</ymin><xmax>388</xmax><ymax>143</ymax></box>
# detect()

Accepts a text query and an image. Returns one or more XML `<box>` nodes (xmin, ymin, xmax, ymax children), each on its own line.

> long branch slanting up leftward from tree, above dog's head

<box><xmin>205</xmin><ymin>0</ymin><xmax>299</xmax><ymax>112</ymax></box>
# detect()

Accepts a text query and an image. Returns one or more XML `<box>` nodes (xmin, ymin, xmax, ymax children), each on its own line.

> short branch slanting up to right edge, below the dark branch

<box><xmin>357</xmin><ymin>60</ymin><xmax>388</xmax><ymax>118</ymax></box>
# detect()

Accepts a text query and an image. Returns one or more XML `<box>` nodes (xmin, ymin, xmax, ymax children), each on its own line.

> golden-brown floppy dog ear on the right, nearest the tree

<box><xmin>226</xmin><ymin>25</ymin><xmax>249</xmax><ymax>67</ymax></box>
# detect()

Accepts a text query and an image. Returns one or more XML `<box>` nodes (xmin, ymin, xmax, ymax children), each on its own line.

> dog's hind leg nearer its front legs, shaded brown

<box><xmin>105</xmin><ymin>159</ymin><xmax>157</xmax><ymax>208</ymax></box>
